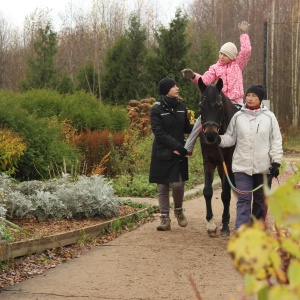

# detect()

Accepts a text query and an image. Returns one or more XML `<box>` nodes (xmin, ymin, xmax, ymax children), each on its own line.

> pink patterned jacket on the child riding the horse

<box><xmin>192</xmin><ymin>33</ymin><xmax>251</xmax><ymax>103</ymax></box>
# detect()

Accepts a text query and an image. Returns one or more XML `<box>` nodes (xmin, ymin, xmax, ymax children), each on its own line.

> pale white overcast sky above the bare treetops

<box><xmin>0</xmin><ymin>0</ymin><xmax>192</xmax><ymax>27</ymax></box>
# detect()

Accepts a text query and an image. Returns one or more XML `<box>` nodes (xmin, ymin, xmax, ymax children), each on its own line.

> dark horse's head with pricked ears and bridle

<box><xmin>198</xmin><ymin>77</ymin><xmax>224</xmax><ymax>144</ymax></box>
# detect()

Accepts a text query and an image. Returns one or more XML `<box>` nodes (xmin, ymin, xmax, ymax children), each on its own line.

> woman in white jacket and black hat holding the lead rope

<box><xmin>218</xmin><ymin>84</ymin><xmax>283</xmax><ymax>229</ymax></box>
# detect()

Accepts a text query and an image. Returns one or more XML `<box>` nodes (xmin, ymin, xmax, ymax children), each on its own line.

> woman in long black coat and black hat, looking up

<box><xmin>149</xmin><ymin>77</ymin><xmax>193</xmax><ymax>231</ymax></box>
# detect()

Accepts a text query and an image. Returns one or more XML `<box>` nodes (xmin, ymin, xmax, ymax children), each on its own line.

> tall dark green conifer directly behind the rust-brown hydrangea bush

<box><xmin>102</xmin><ymin>15</ymin><xmax>146</xmax><ymax>104</ymax></box>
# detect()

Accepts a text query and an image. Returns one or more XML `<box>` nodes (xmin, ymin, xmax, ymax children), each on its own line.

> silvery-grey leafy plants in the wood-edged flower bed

<box><xmin>0</xmin><ymin>174</ymin><xmax>119</xmax><ymax>220</ymax></box>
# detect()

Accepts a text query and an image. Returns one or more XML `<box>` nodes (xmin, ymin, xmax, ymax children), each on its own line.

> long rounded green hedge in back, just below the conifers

<box><xmin>14</xmin><ymin>90</ymin><xmax>128</xmax><ymax>131</ymax></box>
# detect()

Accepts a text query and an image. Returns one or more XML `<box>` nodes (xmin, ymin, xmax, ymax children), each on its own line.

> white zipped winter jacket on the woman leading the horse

<box><xmin>220</xmin><ymin>104</ymin><xmax>283</xmax><ymax>176</ymax></box>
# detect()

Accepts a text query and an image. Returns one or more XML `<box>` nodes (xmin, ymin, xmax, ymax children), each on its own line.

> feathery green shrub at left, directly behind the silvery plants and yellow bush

<box><xmin>0</xmin><ymin>97</ymin><xmax>80</xmax><ymax>180</ymax></box>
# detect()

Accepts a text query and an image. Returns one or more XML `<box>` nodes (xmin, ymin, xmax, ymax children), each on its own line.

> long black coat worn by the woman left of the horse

<box><xmin>149</xmin><ymin>96</ymin><xmax>193</xmax><ymax>183</ymax></box>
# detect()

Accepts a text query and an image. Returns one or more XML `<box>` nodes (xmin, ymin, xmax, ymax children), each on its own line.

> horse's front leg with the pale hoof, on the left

<box><xmin>203</xmin><ymin>170</ymin><xmax>218</xmax><ymax>236</ymax></box>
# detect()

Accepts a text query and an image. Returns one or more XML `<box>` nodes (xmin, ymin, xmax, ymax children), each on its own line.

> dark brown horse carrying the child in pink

<box><xmin>198</xmin><ymin>77</ymin><xmax>238</xmax><ymax>236</ymax></box>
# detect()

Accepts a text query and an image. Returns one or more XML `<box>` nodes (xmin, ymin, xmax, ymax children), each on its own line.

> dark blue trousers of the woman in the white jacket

<box><xmin>234</xmin><ymin>172</ymin><xmax>272</xmax><ymax>229</ymax></box>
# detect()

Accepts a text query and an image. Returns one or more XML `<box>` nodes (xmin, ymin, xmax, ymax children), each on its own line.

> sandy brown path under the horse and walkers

<box><xmin>0</xmin><ymin>158</ymin><xmax>298</xmax><ymax>300</ymax></box>
